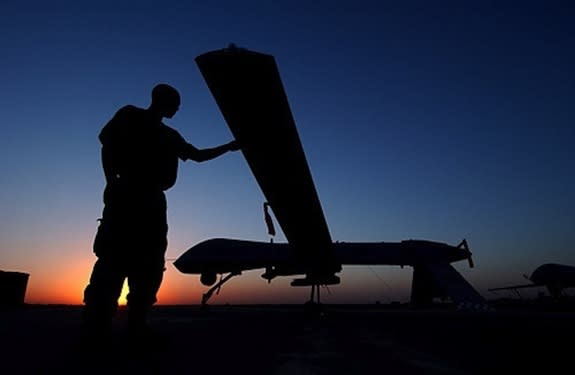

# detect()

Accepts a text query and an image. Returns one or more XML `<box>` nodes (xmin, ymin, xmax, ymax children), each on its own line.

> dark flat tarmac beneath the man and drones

<box><xmin>0</xmin><ymin>305</ymin><xmax>575</xmax><ymax>375</ymax></box>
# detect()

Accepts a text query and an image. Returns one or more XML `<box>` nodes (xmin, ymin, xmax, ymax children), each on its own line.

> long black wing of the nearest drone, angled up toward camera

<box><xmin>195</xmin><ymin>48</ymin><xmax>341</xmax><ymax>283</ymax></box>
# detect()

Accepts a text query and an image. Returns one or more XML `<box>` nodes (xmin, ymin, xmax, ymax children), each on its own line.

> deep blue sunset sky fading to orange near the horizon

<box><xmin>0</xmin><ymin>0</ymin><xmax>575</xmax><ymax>304</ymax></box>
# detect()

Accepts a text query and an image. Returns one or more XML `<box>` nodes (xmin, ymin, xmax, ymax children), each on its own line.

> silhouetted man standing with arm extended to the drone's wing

<box><xmin>83</xmin><ymin>84</ymin><xmax>239</xmax><ymax>342</ymax></box>
